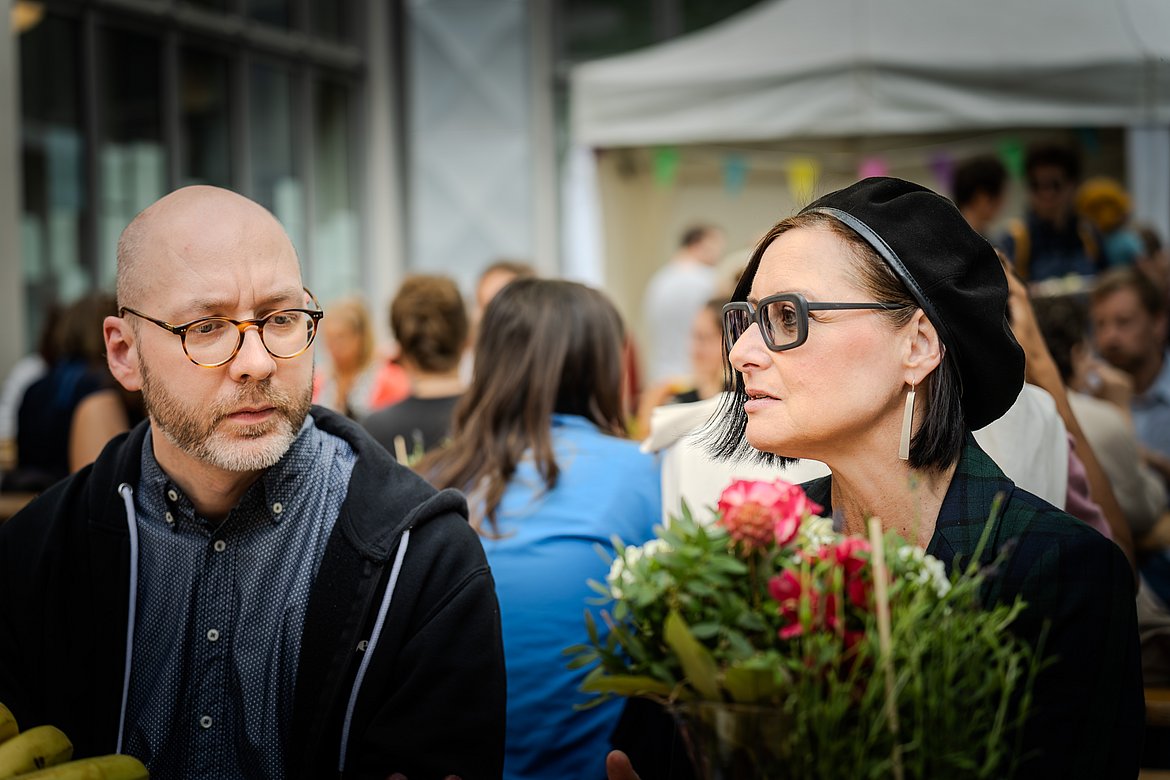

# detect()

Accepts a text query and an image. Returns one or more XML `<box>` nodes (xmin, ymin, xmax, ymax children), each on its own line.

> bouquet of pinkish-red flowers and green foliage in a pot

<box><xmin>566</xmin><ymin>481</ymin><xmax>1041</xmax><ymax>779</ymax></box>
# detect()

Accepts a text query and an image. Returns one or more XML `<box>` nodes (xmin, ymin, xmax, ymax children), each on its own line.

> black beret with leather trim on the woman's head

<box><xmin>801</xmin><ymin>177</ymin><xmax>1024</xmax><ymax>430</ymax></box>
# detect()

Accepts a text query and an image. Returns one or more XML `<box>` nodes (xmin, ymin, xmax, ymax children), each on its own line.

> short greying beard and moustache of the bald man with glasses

<box><xmin>140</xmin><ymin>363</ymin><xmax>312</xmax><ymax>471</ymax></box>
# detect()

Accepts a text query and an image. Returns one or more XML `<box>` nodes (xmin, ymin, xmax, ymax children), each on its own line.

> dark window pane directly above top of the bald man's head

<box><xmin>179</xmin><ymin>49</ymin><xmax>232</xmax><ymax>187</ymax></box>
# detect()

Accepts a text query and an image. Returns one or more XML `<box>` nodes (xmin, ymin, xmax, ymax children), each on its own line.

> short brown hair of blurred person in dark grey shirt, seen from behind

<box><xmin>390</xmin><ymin>275</ymin><xmax>469</xmax><ymax>373</ymax></box>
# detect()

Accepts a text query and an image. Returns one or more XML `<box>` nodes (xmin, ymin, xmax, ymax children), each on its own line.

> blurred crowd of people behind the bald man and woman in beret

<box><xmin>0</xmin><ymin>138</ymin><xmax>1170</xmax><ymax>776</ymax></box>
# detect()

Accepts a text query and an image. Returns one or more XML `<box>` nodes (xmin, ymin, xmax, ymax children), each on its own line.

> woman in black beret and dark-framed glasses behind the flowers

<box><xmin>610</xmin><ymin>178</ymin><xmax>1144</xmax><ymax>778</ymax></box>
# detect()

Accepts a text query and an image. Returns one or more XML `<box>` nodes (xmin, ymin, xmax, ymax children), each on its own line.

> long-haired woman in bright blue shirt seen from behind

<box><xmin>419</xmin><ymin>278</ymin><xmax>661</xmax><ymax>780</ymax></box>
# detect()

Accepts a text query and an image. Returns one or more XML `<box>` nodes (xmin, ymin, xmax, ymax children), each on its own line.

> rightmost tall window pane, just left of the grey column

<box><xmin>309</xmin><ymin>80</ymin><xmax>363</xmax><ymax>301</ymax></box>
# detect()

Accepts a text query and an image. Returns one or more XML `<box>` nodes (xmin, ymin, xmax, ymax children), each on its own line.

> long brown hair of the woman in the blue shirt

<box><xmin>418</xmin><ymin>278</ymin><xmax>625</xmax><ymax>534</ymax></box>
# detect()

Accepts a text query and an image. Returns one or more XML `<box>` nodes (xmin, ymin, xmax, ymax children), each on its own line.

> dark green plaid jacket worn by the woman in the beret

<box><xmin>805</xmin><ymin>433</ymin><xmax>1145</xmax><ymax>780</ymax></box>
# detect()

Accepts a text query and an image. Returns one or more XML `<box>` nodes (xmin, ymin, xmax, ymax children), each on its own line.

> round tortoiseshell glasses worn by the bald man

<box><xmin>118</xmin><ymin>289</ymin><xmax>325</xmax><ymax>368</ymax></box>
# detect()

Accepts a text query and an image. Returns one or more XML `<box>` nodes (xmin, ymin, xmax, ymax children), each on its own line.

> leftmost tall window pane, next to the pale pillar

<box><xmin>18</xmin><ymin>14</ymin><xmax>85</xmax><ymax>343</ymax></box>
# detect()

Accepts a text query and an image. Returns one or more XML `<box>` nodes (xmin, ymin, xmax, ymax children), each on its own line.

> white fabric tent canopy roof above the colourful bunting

<box><xmin>572</xmin><ymin>0</ymin><xmax>1170</xmax><ymax>147</ymax></box>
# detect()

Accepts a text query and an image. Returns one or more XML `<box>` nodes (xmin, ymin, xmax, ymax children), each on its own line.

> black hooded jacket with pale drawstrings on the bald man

<box><xmin>0</xmin><ymin>407</ymin><xmax>505</xmax><ymax>780</ymax></box>
